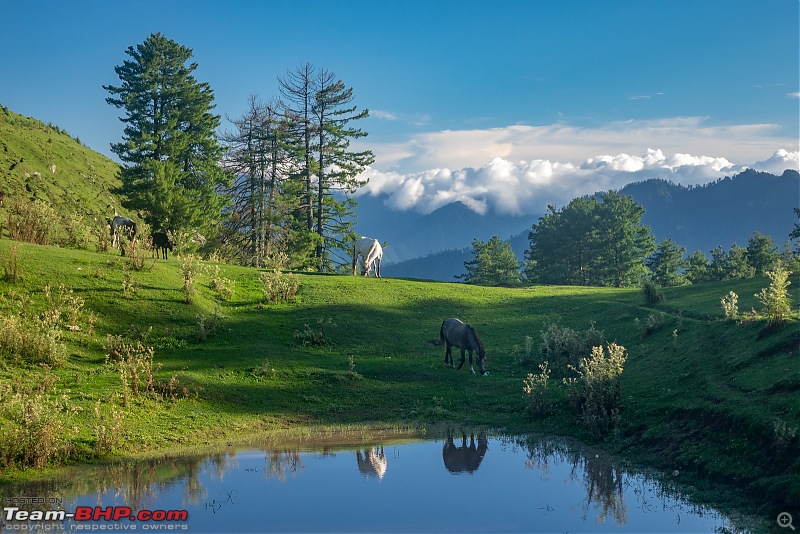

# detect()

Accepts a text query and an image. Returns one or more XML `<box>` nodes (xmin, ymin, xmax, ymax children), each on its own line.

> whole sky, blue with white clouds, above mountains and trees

<box><xmin>0</xmin><ymin>0</ymin><xmax>800</xmax><ymax>216</ymax></box>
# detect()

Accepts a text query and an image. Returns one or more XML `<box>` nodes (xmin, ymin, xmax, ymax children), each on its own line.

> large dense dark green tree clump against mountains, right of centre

<box><xmin>525</xmin><ymin>191</ymin><xmax>655</xmax><ymax>287</ymax></box>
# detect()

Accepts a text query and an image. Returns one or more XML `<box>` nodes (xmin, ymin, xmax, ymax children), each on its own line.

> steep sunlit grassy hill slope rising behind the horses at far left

<box><xmin>0</xmin><ymin>106</ymin><xmax>122</xmax><ymax>220</ymax></box>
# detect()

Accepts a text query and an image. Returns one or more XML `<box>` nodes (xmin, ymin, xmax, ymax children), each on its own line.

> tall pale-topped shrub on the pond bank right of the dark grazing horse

<box><xmin>564</xmin><ymin>343</ymin><xmax>627</xmax><ymax>437</ymax></box>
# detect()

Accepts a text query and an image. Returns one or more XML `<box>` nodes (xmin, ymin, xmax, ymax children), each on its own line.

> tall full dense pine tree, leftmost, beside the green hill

<box><xmin>103</xmin><ymin>33</ymin><xmax>229</xmax><ymax>237</ymax></box>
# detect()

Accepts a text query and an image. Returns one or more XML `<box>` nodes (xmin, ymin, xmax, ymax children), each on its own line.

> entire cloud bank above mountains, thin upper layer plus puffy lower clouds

<box><xmin>358</xmin><ymin>118</ymin><xmax>800</xmax><ymax>215</ymax></box>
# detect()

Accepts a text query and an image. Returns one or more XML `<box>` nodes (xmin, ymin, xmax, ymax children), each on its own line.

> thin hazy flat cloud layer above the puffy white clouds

<box><xmin>369</xmin><ymin>117</ymin><xmax>797</xmax><ymax>173</ymax></box>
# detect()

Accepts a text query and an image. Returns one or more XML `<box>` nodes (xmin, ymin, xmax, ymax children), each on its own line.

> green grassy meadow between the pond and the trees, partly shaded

<box><xmin>0</xmin><ymin>240</ymin><xmax>800</xmax><ymax>516</ymax></box>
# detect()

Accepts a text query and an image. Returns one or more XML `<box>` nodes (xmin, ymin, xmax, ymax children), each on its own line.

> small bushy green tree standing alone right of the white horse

<box><xmin>458</xmin><ymin>236</ymin><xmax>522</xmax><ymax>285</ymax></box>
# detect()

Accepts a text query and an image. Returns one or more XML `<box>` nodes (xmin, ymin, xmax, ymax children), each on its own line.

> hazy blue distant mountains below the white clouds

<box><xmin>357</xmin><ymin>170</ymin><xmax>800</xmax><ymax>281</ymax></box>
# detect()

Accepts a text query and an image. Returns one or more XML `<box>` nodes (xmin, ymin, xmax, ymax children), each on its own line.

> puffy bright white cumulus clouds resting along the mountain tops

<box><xmin>359</xmin><ymin>148</ymin><xmax>800</xmax><ymax>215</ymax></box>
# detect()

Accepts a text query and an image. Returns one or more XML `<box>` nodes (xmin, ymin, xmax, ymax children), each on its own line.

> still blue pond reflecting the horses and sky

<box><xmin>0</xmin><ymin>429</ymin><xmax>752</xmax><ymax>532</ymax></box>
